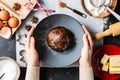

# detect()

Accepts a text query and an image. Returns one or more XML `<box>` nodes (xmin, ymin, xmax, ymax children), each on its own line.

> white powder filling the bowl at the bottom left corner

<box><xmin>0</xmin><ymin>60</ymin><xmax>18</xmax><ymax>80</ymax></box>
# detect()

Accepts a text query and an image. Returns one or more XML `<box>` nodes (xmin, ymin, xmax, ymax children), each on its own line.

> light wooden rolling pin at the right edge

<box><xmin>95</xmin><ymin>22</ymin><xmax>120</xmax><ymax>40</ymax></box>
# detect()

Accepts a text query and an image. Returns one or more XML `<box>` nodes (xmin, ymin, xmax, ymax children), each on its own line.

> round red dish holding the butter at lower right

<box><xmin>92</xmin><ymin>44</ymin><xmax>120</xmax><ymax>80</ymax></box>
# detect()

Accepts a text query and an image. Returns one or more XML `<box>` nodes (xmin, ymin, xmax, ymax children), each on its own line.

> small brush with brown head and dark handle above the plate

<box><xmin>59</xmin><ymin>1</ymin><xmax>87</xmax><ymax>18</ymax></box>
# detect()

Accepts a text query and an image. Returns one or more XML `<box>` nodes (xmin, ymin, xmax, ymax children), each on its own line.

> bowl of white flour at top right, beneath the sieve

<box><xmin>82</xmin><ymin>0</ymin><xmax>117</xmax><ymax>18</ymax></box>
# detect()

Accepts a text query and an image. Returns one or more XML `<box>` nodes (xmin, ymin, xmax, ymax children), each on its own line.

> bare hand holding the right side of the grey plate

<box><xmin>79</xmin><ymin>25</ymin><xmax>93</xmax><ymax>67</ymax></box>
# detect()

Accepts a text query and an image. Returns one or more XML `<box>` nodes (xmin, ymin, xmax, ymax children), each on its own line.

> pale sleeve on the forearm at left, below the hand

<box><xmin>25</xmin><ymin>66</ymin><xmax>40</xmax><ymax>80</ymax></box>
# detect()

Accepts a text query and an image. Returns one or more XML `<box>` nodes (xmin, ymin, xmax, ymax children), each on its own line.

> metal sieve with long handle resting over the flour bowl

<box><xmin>90</xmin><ymin>0</ymin><xmax>120</xmax><ymax>21</ymax></box>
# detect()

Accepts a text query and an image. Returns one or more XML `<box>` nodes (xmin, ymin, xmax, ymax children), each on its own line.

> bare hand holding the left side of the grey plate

<box><xmin>26</xmin><ymin>27</ymin><xmax>39</xmax><ymax>67</ymax></box>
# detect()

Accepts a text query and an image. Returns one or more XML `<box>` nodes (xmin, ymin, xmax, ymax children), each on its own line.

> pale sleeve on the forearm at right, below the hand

<box><xmin>79</xmin><ymin>67</ymin><xmax>94</xmax><ymax>80</ymax></box>
